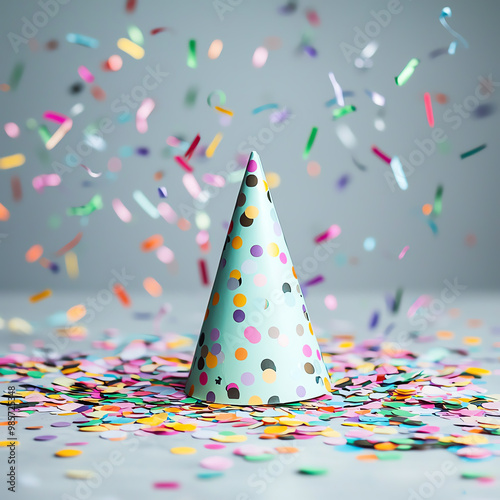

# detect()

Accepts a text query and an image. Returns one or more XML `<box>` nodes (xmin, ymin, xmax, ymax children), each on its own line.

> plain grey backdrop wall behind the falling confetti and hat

<box><xmin>0</xmin><ymin>0</ymin><xmax>500</xmax><ymax>293</ymax></box>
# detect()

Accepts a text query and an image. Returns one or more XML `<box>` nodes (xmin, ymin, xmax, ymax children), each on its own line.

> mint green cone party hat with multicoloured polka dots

<box><xmin>186</xmin><ymin>152</ymin><xmax>330</xmax><ymax>405</ymax></box>
